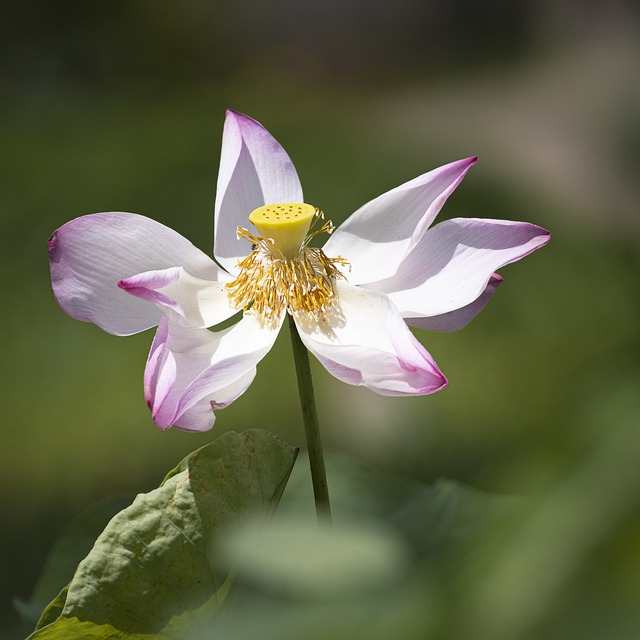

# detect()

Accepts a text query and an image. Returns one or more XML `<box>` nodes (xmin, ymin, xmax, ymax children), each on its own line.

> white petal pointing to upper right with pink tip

<box><xmin>324</xmin><ymin>157</ymin><xmax>477</xmax><ymax>284</ymax></box>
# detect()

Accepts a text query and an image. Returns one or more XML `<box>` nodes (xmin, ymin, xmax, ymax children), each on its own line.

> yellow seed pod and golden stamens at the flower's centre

<box><xmin>226</xmin><ymin>202</ymin><xmax>348</xmax><ymax>326</ymax></box>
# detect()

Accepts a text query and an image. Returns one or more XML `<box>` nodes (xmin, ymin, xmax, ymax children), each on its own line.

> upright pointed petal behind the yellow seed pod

<box><xmin>213</xmin><ymin>111</ymin><xmax>302</xmax><ymax>273</ymax></box>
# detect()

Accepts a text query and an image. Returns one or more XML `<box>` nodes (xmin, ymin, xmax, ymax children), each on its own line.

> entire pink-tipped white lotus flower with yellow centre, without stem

<box><xmin>49</xmin><ymin>111</ymin><xmax>549</xmax><ymax>431</ymax></box>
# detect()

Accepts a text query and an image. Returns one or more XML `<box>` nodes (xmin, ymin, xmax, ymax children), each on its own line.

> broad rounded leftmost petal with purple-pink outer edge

<box><xmin>49</xmin><ymin>212</ymin><xmax>220</xmax><ymax>335</ymax></box>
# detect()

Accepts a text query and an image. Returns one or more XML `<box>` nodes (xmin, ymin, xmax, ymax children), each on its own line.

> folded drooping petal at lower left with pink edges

<box><xmin>145</xmin><ymin>313</ymin><xmax>280</xmax><ymax>431</ymax></box>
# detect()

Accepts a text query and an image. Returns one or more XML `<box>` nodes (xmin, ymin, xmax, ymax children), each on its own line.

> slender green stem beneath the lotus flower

<box><xmin>289</xmin><ymin>315</ymin><xmax>331</xmax><ymax>523</ymax></box>
